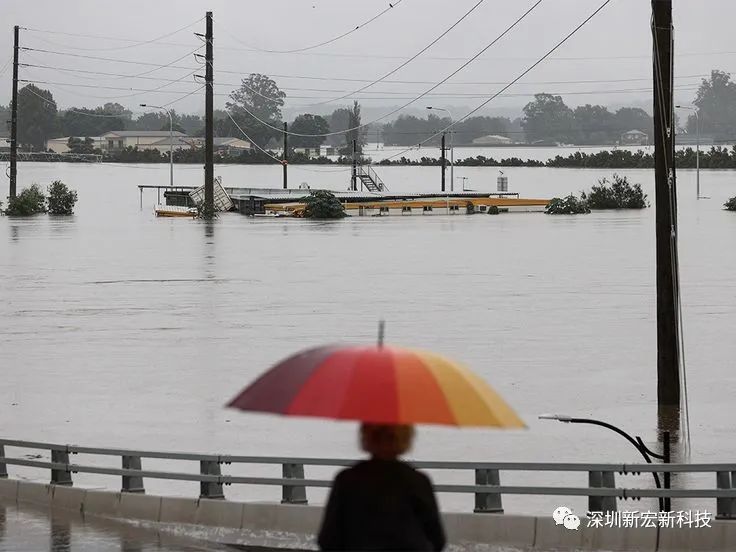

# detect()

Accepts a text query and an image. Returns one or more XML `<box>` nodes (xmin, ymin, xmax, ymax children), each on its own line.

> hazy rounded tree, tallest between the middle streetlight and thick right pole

<box><xmin>522</xmin><ymin>93</ymin><xmax>575</xmax><ymax>143</ymax></box>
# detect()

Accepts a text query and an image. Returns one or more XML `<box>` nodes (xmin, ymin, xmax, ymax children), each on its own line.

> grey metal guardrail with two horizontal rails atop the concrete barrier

<box><xmin>0</xmin><ymin>439</ymin><xmax>736</xmax><ymax>519</ymax></box>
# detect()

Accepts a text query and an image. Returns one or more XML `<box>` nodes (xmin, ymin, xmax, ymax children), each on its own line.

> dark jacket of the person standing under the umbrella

<box><xmin>317</xmin><ymin>460</ymin><xmax>446</xmax><ymax>550</ymax></box>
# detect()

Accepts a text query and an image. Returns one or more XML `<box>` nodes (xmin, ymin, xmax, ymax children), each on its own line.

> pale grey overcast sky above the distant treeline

<box><xmin>0</xmin><ymin>0</ymin><xmax>736</xmax><ymax>118</ymax></box>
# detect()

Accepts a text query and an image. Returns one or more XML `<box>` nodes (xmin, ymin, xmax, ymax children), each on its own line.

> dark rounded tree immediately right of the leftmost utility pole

<box><xmin>18</xmin><ymin>84</ymin><xmax>58</xmax><ymax>151</ymax></box>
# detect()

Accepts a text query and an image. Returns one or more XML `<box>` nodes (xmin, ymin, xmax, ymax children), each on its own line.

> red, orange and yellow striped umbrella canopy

<box><xmin>228</xmin><ymin>345</ymin><xmax>526</xmax><ymax>428</ymax></box>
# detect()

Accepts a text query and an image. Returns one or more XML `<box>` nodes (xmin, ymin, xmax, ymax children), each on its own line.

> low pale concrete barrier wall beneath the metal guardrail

<box><xmin>0</xmin><ymin>479</ymin><xmax>736</xmax><ymax>552</ymax></box>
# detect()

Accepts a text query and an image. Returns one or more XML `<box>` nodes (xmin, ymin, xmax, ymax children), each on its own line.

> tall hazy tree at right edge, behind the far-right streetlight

<box><xmin>687</xmin><ymin>69</ymin><xmax>736</xmax><ymax>140</ymax></box>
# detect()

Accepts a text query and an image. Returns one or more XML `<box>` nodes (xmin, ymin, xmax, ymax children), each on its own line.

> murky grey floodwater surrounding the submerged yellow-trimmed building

<box><xmin>0</xmin><ymin>158</ymin><xmax>736</xmax><ymax>513</ymax></box>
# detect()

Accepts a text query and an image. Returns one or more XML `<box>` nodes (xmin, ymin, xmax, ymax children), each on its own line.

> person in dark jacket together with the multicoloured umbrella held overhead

<box><xmin>227</xmin><ymin>326</ymin><xmax>526</xmax><ymax>550</ymax></box>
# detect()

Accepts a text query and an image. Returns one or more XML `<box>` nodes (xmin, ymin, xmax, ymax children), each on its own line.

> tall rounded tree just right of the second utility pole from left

<box><xmin>225</xmin><ymin>73</ymin><xmax>286</xmax><ymax>146</ymax></box>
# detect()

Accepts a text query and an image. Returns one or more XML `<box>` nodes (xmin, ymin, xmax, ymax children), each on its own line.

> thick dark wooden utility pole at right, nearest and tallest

<box><xmin>652</xmin><ymin>0</ymin><xmax>680</xmax><ymax>407</ymax></box>
